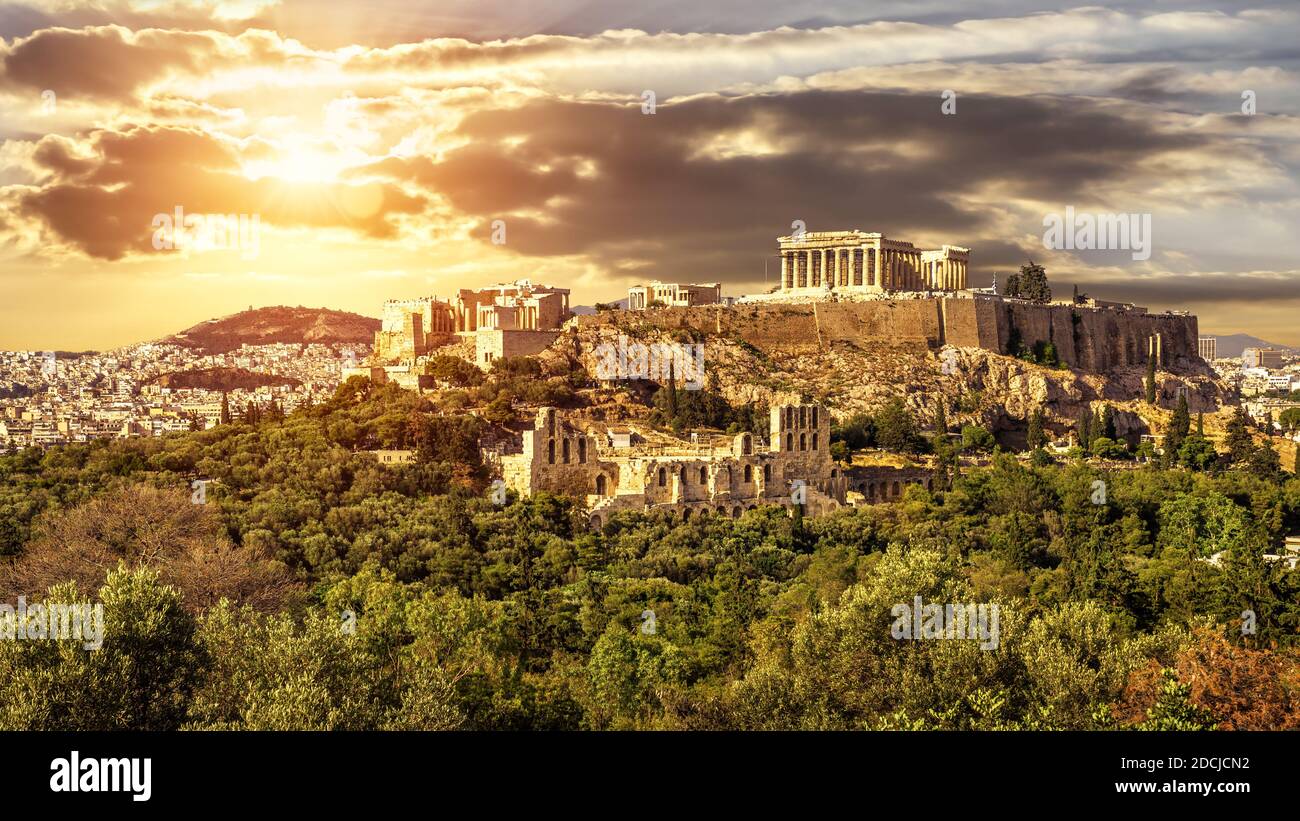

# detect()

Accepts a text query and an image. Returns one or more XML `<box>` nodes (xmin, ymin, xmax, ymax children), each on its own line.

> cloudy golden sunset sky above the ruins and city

<box><xmin>0</xmin><ymin>0</ymin><xmax>1300</xmax><ymax>349</ymax></box>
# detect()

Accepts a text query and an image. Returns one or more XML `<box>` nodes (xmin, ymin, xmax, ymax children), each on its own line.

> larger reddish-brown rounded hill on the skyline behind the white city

<box><xmin>163</xmin><ymin>305</ymin><xmax>380</xmax><ymax>353</ymax></box>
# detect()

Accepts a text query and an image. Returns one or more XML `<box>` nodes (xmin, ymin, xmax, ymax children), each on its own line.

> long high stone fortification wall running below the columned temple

<box><xmin>576</xmin><ymin>297</ymin><xmax>1199</xmax><ymax>373</ymax></box>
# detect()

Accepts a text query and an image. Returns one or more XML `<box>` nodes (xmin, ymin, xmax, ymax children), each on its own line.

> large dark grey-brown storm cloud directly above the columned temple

<box><xmin>356</xmin><ymin>91</ymin><xmax>1205</xmax><ymax>282</ymax></box>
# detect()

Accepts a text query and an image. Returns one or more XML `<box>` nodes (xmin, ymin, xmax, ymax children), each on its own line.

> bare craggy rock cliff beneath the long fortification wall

<box><xmin>542</xmin><ymin>317</ymin><xmax>1229</xmax><ymax>442</ymax></box>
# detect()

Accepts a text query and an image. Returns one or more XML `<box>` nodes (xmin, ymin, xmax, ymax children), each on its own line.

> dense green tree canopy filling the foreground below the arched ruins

<box><xmin>0</xmin><ymin>379</ymin><xmax>1300</xmax><ymax>730</ymax></box>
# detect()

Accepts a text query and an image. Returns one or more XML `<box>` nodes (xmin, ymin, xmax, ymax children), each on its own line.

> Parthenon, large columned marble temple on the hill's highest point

<box><xmin>777</xmin><ymin>230</ymin><xmax>970</xmax><ymax>296</ymax></box>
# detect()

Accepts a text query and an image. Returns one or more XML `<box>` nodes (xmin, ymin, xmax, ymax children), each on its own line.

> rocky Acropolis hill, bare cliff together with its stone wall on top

<box><xmin>540</xmin><ymin>300</ymin><xmax>1230</xmax><ymax>444</ymax></box>
